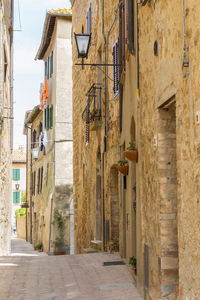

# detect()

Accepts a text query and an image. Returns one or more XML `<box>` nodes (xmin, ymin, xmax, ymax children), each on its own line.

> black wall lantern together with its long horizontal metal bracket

<box><xmin>74</xmin><ymin>33</ymin><xmax>121</xmax><ymax>69</ymax></box>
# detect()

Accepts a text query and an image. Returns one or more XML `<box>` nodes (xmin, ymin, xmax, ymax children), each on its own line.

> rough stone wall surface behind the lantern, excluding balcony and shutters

<box><xmin>72</xmin><ymin>0</ymin><xmax>120</xmax><ymax>253</ymax></box>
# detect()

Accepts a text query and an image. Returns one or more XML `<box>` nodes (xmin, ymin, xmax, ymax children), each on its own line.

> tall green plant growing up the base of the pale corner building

<box><xmin>54</xmin><ymin>209</ymin><xmax>66</xmax><ymax>255</ymax></box>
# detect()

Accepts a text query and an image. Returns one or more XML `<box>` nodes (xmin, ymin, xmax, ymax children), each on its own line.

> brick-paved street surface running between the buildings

<box><xmin>0</xmin><ymin>239</ymin><xmax>142</xmax><ymax>300</ymax></box>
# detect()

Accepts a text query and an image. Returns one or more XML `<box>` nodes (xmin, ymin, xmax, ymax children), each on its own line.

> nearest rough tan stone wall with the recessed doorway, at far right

<box><xmin>137</xmin><ymin>0</ymin><xmax>200</xmax><ymax>299</ymax></box>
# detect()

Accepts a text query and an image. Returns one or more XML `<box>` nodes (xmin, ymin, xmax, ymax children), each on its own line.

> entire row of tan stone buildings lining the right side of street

<box><xmin>71</xmin><ymin>0</ymin><xmax>200</xmax><ymax>300</ymax></box>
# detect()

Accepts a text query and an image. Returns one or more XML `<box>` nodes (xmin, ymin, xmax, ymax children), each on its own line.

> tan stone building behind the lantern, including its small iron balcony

<box><xmin>71</xmin><ymin>0</ymin><xmax>120</xmax><ymax>253</ymax></box>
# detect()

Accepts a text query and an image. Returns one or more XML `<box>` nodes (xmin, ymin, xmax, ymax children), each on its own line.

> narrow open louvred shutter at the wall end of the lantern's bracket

<box><xmin>113</xmin><ymin>40</ymin><xmax>119</xmax><ymax>96</ymax></box>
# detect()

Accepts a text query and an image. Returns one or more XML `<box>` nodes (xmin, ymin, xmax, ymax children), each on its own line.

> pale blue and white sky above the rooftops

<box><xmin>14</xmin><ymin>0</ymin><xmax>71</xmax><ymax>149</ymax></box>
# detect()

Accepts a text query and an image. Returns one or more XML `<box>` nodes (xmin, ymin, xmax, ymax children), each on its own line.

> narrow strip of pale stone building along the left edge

<box><xmin>0</xmin><ymin>0</ymin><xmax>14</xmax><ymax>256</ymax></box>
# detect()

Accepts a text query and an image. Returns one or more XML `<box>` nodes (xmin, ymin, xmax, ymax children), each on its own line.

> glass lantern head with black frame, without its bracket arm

<box><xmin>74</xmin><ymin>33</ymin><xmax>91</xmax><ymax>58</ymax></box>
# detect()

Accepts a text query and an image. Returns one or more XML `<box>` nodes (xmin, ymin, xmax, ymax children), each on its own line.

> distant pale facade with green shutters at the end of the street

<box><xmin>12</xmin><ymin>147</ymin><xmax>26</xmax><ymax>231</ymax></box>
